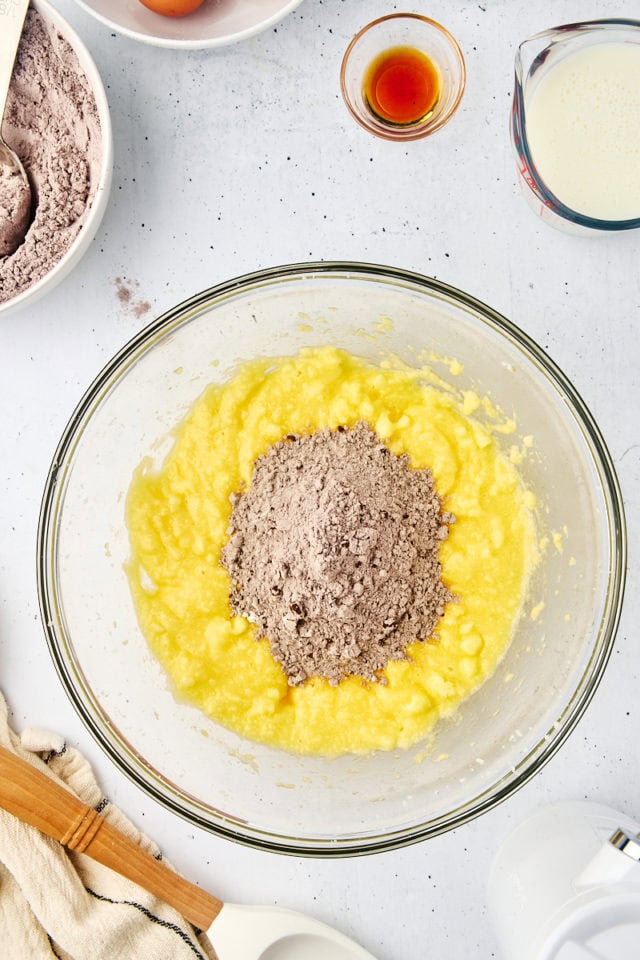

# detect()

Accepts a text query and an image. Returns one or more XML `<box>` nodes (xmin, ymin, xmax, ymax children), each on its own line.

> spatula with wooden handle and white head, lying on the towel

<box><xmin>0</xmin><ymin>747</ymin><xmax>375</xmax><ymax>960</ymax></box>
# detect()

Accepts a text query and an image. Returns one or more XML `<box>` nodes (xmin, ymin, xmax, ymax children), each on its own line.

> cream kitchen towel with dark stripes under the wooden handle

<box><xmin>0</xmin><ymin>693</ymin><xmax>215</xmax><ymax>960</ymax></box>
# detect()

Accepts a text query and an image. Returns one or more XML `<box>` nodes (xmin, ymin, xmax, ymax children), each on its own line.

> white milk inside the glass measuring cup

<box><xmin>526</xmin><ymin>42</ymin><xmax>640</xmax><ymax>220</ymax></box>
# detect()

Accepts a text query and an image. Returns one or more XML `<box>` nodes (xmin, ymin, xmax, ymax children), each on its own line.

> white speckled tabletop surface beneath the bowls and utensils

<box><xmin>0</xmin><ymin>0</ymin><xmax>640</xmax><ymax>960</ymax></box>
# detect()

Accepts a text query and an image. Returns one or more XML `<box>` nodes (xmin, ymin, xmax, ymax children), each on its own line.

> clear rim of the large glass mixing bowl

<box><xmin>36</xmin><ymin>261</ymin><xmax>627</xmax><ymax>858</ymax></box>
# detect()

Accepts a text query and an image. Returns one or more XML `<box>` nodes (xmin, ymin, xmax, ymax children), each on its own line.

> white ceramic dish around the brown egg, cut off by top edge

<box><xmin>76</xmin><ymin>0</ymin><xmax>302</xmax><ymax>50</ymax></box>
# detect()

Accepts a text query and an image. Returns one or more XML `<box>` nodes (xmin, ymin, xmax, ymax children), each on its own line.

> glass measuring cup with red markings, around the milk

<box><xmin>511</xmin><ymin>19</ymin><xmax>640</xmax><ymax>235</ymax></box>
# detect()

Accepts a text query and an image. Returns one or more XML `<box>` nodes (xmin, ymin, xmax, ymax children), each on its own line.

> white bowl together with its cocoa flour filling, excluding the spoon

<box><xmin>0</xmin><ymin>0</ymin><xmax>113</xmax><ymax>315</ymax></box>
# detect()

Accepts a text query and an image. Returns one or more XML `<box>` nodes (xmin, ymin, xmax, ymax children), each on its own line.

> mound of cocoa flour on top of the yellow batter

<box><xmin>222</xmin><ymin>423</ymin><xmax>455</xmax><ymax>686</ymax></box>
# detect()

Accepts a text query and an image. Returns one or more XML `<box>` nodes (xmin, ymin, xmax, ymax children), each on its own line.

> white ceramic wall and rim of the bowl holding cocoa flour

<box><xmin>0</xmin><ymin>0</ymin><xmax>113</xmax><ymax>316</ymax></box>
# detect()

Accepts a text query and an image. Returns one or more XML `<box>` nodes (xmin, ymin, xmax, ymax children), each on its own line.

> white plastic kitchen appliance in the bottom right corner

<box><xmin>488</xmin><ymin>801</ymin><xmax>640</xmax><ymax>960</ymax></box>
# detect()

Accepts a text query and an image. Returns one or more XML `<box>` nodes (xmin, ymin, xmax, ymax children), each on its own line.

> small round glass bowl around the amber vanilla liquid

<box><xmin>340</xmin><ymin>13</ymin><xmax>466</xmax><ymax>140</ymax></box>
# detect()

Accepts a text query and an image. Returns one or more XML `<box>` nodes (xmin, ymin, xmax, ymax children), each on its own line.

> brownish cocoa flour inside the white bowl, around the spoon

<box><xmin>0</xmin><ymin>9</ymin><xmax>102</xmax><ymax>303</ymax></box>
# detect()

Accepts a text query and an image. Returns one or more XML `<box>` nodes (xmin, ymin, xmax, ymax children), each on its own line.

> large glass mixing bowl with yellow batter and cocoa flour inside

<box><xmin>39</xmin><ymin>263</ymin><xmax>626</xmax><ymax>855</ymax></box>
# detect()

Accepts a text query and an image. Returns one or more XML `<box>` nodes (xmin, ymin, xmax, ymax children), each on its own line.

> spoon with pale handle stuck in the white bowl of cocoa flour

<box><xmin>0</xmin><ymin>0</ymin><xmax>31</xmax><ymax>257</ymax></box>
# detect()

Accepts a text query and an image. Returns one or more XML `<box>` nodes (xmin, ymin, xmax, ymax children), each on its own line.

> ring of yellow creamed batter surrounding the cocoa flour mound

<box><xmin>127</xmin><ymin>347</ymin><xmax>536</xmax><ymax>755</ymax></box>
